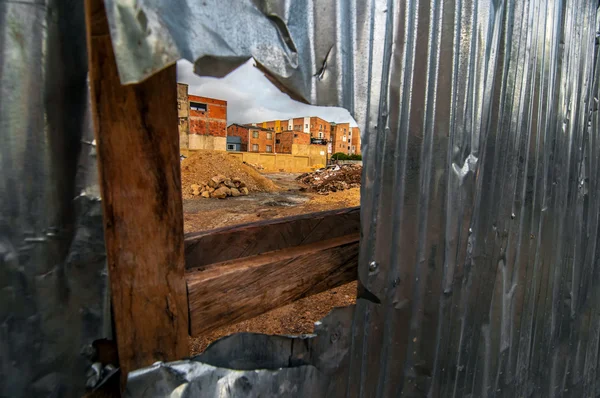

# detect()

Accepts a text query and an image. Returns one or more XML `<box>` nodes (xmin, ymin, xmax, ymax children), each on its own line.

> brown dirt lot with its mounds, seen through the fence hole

<box><xmin>181</xmin><ymin>151</ymin><xmax>361</xmax><ymax>355</ymax></box>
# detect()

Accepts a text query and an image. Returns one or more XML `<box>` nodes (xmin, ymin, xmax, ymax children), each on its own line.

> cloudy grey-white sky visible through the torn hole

<box><xmin>177</xmin><ymin>59</ymin><xmax>356</xmax><ymax>126</ymax></box>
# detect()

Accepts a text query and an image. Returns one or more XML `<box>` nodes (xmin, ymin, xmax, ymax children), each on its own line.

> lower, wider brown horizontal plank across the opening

<box><xmin>187</xmin><ymin>233</ymin><xmax>359</xmax><ymax>336</ymax></box>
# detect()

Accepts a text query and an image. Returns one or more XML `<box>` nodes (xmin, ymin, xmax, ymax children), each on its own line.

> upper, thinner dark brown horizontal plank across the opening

<box><xmin>185</xmin><ymin>207</ymin><xmax>360</xmax><ymax>270</ymax></box>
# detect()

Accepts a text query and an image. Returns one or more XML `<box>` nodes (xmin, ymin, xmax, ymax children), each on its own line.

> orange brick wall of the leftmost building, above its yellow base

<box><xmin>188</xmin><ymin>95</ymin><xmax>227</xmax><ymax>137</ymax></box>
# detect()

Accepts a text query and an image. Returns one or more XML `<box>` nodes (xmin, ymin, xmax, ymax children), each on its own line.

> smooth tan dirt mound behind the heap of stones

<box><xmin>181</xmin><ymin>151</ymin><xmax>279</xmax><ymax>199</ymax></box>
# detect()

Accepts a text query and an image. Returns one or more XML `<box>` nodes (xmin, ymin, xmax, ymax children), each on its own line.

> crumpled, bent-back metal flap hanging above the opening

<box><xmin>105</xmin><ymin>0</ymin><xmax>360</xmax><ymax>109</ymax></box>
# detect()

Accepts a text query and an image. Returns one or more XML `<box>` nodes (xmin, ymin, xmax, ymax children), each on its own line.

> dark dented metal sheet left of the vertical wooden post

<box><xmin>0</xmin><ymin>0</ymin><xmax>110</xmax><ymax>397</ymax></box>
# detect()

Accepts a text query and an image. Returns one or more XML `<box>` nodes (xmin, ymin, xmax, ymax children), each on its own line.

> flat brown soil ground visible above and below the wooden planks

<box><xmin>183</xmin><ymin>173</ymin><xmax>360</xmax><ymax>355</ymax></box>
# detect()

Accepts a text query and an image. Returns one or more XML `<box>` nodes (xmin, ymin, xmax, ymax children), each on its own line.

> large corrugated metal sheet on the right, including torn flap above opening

<box><xmin>107</xmin><ymin>0</ymin><xmax>600</xmax><ymax>397</ymax></box>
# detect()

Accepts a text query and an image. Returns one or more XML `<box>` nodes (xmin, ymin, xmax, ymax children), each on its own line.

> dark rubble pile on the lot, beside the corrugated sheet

<box><xmin>296</xmin><ymin>164</ymin><xmax>362</xmax><ymax>194</ymax></box>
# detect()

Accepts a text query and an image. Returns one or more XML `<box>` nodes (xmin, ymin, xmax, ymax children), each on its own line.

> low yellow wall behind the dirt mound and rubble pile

<box><xmin>228</xmin><ymin>152</ymin><xmax>325</xmax><ymax>173</ymax></box>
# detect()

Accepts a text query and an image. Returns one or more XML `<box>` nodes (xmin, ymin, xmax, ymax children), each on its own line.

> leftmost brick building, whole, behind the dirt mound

<box><xmin>177</xmin><ymin>83</ymin><xmax>227</xmax><ymax>151</ymax></box>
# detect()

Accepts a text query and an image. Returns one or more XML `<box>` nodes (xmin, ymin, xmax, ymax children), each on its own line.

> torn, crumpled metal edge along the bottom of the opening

<box><xmin>126</xmin><ymin>307</ymin><xmax>354</xmax><ymax>398</ymax></box>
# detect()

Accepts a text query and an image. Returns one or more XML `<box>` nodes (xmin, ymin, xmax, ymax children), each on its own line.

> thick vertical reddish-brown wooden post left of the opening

<box><xmin>86</xmin><ymin>0</ymin><xmax>188</xmax><ymax>380</ymax></box>
